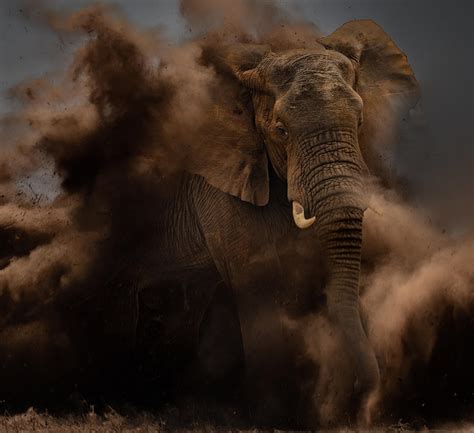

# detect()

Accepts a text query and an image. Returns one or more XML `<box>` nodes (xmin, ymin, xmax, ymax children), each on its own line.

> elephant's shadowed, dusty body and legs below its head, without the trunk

<box><xmin>131</xmin><ymin>175</ymin><xmax>325</xmax><ymax>425</ymax></box>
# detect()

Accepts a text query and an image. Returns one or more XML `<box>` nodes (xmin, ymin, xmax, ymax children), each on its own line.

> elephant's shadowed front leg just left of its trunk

<box><xmin>210</xmin><ymin>262</ymin><xmax>317</xmax><ymax>429</ymax></box>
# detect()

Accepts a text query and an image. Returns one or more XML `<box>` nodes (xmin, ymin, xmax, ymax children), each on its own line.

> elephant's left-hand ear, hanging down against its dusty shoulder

<box><xmin>189</xmin><ymin>44</ymin><xmax>269</xmax><ymax>206</ymax></box>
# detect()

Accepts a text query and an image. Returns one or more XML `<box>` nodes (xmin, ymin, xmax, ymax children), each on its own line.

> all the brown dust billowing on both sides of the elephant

<box><xmin>0</xmin><ymin>0</ymin><xmax>474</xmax><ymax>428</ymax></box>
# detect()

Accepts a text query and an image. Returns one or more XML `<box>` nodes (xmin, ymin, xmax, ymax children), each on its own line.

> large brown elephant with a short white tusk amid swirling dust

<box><xmin>0</xmin><ymin>20</ymin><xmax>419</xmax><ymax>424</ymax></box>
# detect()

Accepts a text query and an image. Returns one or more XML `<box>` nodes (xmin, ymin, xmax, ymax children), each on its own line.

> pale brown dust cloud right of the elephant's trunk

<box><xmin>362</xmin><ymin>184</ymin><xmax>474</xmax><ymax>424</ymax></box>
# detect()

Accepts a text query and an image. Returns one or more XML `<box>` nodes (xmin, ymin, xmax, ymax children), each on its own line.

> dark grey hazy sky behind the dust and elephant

<box><xmin>0</xmin><ymin>0</ymin><xmax>474</xmax><ymax>228</ymax></box>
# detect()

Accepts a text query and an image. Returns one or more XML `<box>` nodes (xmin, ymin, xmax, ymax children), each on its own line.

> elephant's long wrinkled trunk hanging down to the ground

<box><xmin>288</xmin><ymin>130</ymin><xmax>379</xmax><ymax>418</ymax></box>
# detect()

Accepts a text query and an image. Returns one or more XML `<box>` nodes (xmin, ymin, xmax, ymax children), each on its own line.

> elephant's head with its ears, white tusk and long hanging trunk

<box><xmin>189</xmin><ymin>21</ymin><xmax>418</xmax><ymax>422</ymax></box>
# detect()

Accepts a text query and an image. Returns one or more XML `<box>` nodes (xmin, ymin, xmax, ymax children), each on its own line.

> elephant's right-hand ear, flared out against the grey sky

<box><xmin>320</xmin><ymin>20</ymin><xmax>420</xmax><ymax>181</ymax></box>
